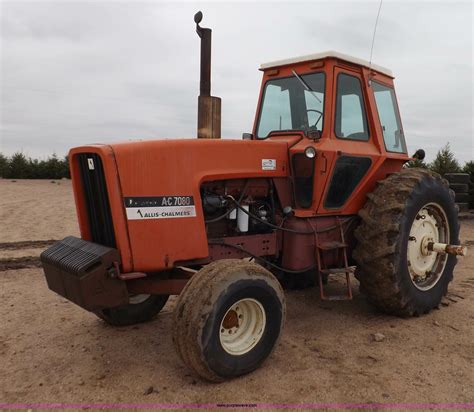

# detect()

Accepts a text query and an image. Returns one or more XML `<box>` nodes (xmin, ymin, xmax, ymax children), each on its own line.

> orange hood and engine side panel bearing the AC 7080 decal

<box><xmin>111</xmin><ymin>139</ymin><xmax>288</xmax><ymax>272</ymax></box>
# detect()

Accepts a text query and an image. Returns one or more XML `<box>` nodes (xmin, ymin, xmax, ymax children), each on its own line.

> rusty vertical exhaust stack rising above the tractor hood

<box><xmin>194</xmin><ymin>11</ymin><xmax>221</xmax><ymax>139</ymax></box>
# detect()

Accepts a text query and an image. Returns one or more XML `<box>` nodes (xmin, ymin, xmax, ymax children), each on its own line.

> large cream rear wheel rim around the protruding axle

<box><xmin>407</xmin><ymin>203</ymin><xmax>450</xmax><ymax>291</ymax></box>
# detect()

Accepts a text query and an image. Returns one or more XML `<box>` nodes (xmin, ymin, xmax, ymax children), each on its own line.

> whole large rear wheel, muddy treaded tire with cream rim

<box><xmin>353</xmin><ymin>169</ymin><xmax>459</xmax><ymax>316</ymax></box>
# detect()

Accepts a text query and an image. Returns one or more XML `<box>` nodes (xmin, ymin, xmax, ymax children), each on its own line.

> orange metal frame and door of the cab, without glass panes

<box><xmin>254</xmin><ymin>57</ymin><xmax>410</xmax><ymax>217</ymax></box>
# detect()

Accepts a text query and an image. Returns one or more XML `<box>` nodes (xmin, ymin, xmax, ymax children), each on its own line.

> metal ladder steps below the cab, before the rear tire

<box><xmin>314</xmin><ymin>219</ymin><xmax>355</xmax><ymax>300</ymax></box>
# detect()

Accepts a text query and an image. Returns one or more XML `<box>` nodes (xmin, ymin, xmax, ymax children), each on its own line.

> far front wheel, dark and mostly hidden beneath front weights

<box><xmin>95</xmin><ymin>294</ymin><xmax>169</xmax><ymax>326</ymax></box>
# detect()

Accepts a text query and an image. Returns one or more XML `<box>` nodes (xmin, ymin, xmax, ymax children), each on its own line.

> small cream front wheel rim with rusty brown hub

<box><xmin>219</xmin><ymin>298</ymin><xmax>266</xmax><ymax>356</ymax></box>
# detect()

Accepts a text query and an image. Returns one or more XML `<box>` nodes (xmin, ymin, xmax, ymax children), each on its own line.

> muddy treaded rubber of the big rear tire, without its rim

<box><xmin>353</xmin><ymin>169</ymin><xmax>459</xmax><ymax>316</ymax></box>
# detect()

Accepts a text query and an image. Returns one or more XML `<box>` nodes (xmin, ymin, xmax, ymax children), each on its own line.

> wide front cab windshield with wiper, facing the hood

<box><xmin>257</xmin><ymin>73</ymin><xmax>325</xmax><ymax>139</ymax></box>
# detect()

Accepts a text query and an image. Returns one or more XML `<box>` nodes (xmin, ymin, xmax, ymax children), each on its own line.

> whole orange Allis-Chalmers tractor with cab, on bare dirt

<box><xmin>41</xmin><ymin>14</ymin><xmax>465</xmax><ymax>381</ymax></box>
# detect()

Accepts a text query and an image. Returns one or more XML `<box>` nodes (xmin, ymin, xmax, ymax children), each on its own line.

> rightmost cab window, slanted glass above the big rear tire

<box><xmin>372</xmin><ymin>82</ymin><xmax>407</xmax><ymax>153</ymax></box>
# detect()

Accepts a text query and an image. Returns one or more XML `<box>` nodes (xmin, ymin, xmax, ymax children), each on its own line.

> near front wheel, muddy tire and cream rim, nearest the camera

<box><xmin>173</xmin><ymin>259</ymin><xmax>286</xmax><ymax>382</ymax></box>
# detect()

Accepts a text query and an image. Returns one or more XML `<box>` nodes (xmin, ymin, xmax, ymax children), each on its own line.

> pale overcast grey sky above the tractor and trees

<box><xmin>0</xmin><ymin>0</ymin><xmax>474</xmax><ymax>162</ymax></box>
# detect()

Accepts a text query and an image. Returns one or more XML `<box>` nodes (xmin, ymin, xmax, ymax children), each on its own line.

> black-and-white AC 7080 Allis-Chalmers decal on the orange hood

<box><xmin>123</xmin><ymin>196</ymin><xmax>196</xmax><ymax>220</ymax></box>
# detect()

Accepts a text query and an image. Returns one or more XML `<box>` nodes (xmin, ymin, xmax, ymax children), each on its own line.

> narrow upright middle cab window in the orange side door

<box><xmin>335</xmin><ymin>73</ymin><xmax>369</xmax><ymax>141</ymax></box>
